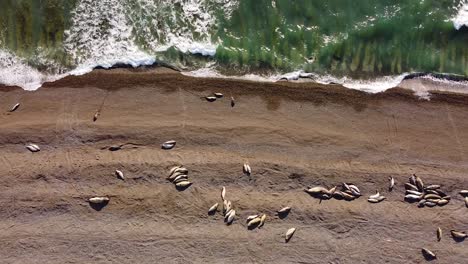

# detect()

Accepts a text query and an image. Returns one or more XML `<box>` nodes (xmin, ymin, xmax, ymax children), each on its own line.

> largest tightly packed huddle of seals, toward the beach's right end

<box><xmin>405</xmin><ymin>174</ymin><xmax>450</xmax><ymax>207</ymax></box>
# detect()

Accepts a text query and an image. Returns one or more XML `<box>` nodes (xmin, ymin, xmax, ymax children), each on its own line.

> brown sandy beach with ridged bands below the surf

<box><xmin>0</xmin><ymin>69</ymin><xmax>468</xmax><ymax>263</ymax></box>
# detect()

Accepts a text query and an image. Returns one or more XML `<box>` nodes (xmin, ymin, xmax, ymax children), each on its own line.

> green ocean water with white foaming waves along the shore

<box><xmin>0</xmin><ymin>0</ymin><xmax>468</xmax><ymax>92</ymax></box>
